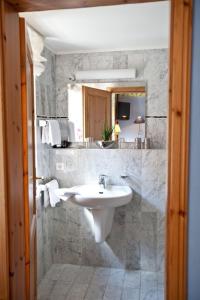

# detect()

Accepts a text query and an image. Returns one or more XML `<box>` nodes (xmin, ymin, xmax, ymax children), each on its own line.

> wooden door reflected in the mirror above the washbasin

<box><xmin>82</xmin><ymin>86</ymin><xmax>111</xmax><ymax>140</ymax></box>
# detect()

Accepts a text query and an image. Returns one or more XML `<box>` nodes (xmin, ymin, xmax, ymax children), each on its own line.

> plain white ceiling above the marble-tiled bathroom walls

<box><xmin>23</xmin><ymin>1</ymin><xmax>170</xmax><ymax>54</ymax></box>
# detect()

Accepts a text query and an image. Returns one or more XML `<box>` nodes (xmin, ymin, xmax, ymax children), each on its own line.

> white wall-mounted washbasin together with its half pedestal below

<box><xmin>56</xmin><ymin>184</ymin><xmax>132</xmax><ymax>243</ymax></box>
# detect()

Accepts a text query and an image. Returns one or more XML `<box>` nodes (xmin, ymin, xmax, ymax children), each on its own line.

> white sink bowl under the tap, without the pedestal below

<box><xmin>57</xmin><ymin>184</ymin><xmax>132</xmax><ymax>208</ymax></box>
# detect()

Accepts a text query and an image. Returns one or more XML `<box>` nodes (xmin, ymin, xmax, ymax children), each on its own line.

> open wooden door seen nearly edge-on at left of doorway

<box><xmin>19</xmin><ymin>18</ymin><xmax>36</xmax><ymax>300</ymax></box>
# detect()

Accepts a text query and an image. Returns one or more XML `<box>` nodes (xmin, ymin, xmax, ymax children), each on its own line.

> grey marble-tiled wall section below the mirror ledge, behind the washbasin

<box><xmin>36</xmin><ymin>149</ymin><xmax>166</xmax><ymax>282</ymax></box>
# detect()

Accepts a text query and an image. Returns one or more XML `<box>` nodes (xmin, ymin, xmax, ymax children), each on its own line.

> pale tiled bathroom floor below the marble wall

<box><xmin>38</xmin><ymin>264</ymin><xmax>164</xmax><ymax>300</ymax></box>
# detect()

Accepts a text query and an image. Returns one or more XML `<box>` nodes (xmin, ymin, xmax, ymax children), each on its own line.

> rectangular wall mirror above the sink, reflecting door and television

<box><xmin>68</xmin><ymin>82</ymin><xmax>147</xmax><ymax>145</ymax></box>
